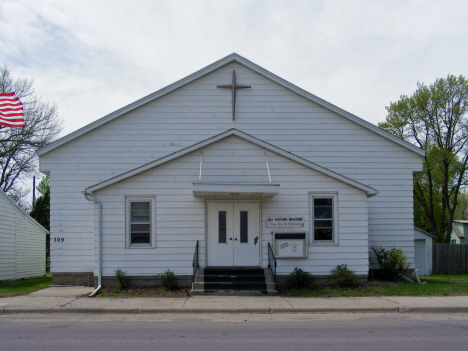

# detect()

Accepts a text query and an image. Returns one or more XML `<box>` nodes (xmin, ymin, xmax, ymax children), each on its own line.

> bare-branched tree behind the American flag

<box><xmin>0</xmin><ymin>66</ymin><xmax>62</xmax><ymax>197</ymax></box>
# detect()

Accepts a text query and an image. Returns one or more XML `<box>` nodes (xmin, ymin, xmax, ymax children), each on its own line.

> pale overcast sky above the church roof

<box><xmin>0</xmin><ymin>0</ymin><xmax>468</xmax><ymax>136</ymax></box>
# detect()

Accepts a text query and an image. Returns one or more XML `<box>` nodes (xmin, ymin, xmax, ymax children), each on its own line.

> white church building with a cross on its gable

<box><xmin>38</xmin><ymin>54</ymin><xmax>424</xmax><ymax>291</ymax></box>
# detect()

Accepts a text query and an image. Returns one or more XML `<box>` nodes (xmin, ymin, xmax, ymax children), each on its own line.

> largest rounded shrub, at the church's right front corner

<box><xmin>370</xmin><ymin>246</ymin><xmax>411</xmax><ymax>281</ymax></box>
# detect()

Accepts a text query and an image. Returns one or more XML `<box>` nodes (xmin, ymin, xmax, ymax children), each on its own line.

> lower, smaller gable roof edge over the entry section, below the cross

<box><xmin>85</xmin><ymin>129</ymin><xmax>378</xmax><ymax>196</ymax></box>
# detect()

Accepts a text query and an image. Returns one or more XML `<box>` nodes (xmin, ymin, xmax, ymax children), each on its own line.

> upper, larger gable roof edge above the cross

<box><xmin>37</xmin><ymin>53</ymin><xmax>425</xmax><ymax>156</ymax></box>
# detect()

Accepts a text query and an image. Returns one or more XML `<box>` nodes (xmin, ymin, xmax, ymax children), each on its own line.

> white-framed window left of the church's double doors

<box><xmin>126</xmin><ymin>198</ymin><xmax>155</xmax><ymax>247</ymax></box>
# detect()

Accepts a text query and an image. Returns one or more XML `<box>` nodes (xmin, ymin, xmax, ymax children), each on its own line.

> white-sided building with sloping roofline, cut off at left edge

<box><xmin>0</xmin><ymin>190</ymin><xmax>49</xmax><ymax>281</ymax></box>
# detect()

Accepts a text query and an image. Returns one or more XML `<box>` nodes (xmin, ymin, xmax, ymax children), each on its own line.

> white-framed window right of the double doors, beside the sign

<box><xmin>310</xmin><ymin>195</ymin><xmax>338</xmax><ymax>244</ymax></box>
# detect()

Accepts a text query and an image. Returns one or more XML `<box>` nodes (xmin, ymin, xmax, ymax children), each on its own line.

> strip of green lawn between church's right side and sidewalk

<box><xmin>282</xmin><ymin>276</ymin><xmax>468</xmax><ymax>297</ymax></box>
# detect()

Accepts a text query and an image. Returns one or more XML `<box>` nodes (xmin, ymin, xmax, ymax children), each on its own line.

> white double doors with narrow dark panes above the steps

<box><xmin>207</xmin><ymin>202</ymin><xmax>260</xmax><ymax>267</ymax></box>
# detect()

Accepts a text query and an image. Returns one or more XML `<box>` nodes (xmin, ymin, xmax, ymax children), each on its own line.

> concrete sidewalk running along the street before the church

<box><xmin>0</xmin><ymin>287</ymin><xmax>468</xmax><ymax>314</ymax></box>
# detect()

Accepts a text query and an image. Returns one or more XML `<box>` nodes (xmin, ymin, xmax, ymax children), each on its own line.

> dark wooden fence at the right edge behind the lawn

<box><xmin>432</xmin><ymin>243</ymin><xmax>468</xmax><ymax>274</ymax></box>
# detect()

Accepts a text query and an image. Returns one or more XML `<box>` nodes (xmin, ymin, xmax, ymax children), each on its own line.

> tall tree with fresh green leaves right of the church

<box><xmin>379</xmin><ymin>75</ymin><xmax>468</xmax><ymax>243</ymax></box>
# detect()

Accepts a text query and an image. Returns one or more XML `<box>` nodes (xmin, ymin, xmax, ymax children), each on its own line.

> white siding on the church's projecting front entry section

<box><xmin>91</xmin><ymin>136</ymin><xmax>368</xmax><ymax>276</ymax></box>
